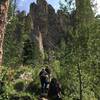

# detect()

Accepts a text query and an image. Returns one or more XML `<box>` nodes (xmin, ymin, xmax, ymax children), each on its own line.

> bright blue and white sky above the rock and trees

<box><xmin>17</xmin><ymin>0</ymin><xmax>100</xmax><ymax>14</ymax></box>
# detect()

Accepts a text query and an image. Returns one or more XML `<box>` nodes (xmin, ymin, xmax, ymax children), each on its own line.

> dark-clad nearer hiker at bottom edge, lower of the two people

<box><xmin>48</xmin><ymin>78</ymin><xmax>62</xmax><ymax>100</ymax></box>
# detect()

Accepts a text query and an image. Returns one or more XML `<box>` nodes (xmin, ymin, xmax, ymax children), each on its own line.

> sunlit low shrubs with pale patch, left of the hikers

<box><xmin>0</xmin><ymin>65</ymin><xmax>41</xmax><ymax>100</ymax></box>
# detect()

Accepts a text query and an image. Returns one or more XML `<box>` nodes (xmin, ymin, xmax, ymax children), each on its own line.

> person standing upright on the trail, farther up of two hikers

<box><xmin>39</xmin><ymin>68</ymin><xmax>48</xmax><ymax>93</ymax></box>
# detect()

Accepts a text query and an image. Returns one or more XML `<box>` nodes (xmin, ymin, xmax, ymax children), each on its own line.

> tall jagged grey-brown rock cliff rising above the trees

<box><xmin>30</xmin><ymin>0</ymin><xmax>69</xmax><ymax>49</ymax></box>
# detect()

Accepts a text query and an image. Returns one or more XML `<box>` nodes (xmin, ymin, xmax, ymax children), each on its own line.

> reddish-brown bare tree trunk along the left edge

<box><xmin>0</xmin><ymin>0</ymin><xmax>9</xmax><ymax>66</ymax></box>
